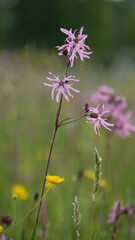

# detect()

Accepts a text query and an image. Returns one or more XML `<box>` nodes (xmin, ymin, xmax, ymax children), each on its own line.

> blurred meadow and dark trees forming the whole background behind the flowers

<box><xmin>0</xmin><ymin>0</ymin><xmax>135</xmax><ymax>240</ymax></box>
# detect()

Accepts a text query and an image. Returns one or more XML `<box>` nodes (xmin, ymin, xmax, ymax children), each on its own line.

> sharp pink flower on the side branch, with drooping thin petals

<box><xmin>87</xmin><ymin>105</ymin><xmax>114</xmax><ymax>136</ymax></box>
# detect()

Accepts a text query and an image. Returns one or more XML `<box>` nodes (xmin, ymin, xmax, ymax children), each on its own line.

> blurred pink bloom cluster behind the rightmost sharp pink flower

<box><xmin>92</xmin><ymin>85</ymin><xmax>135</xmax><ymax>138</ymax></box>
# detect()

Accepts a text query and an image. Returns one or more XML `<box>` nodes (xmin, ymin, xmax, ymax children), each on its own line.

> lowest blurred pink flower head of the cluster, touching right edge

<box><xmin>115</xmin><ymin>111</ymin><xmax>135</xmax><ymax>138</ymax></box>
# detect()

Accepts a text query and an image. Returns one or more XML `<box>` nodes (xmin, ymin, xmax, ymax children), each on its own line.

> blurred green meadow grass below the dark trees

<box><xmin>0</xmin><ymin>48</ymin><xmax>135</xmax><ymax>240</ymax></box>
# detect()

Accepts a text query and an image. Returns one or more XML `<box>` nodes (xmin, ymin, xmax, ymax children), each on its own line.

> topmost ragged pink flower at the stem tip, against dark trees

<box><xmin>57</xmin><ymin>27</ymin><xmax>92</xmax><ymax>67</ymax></box>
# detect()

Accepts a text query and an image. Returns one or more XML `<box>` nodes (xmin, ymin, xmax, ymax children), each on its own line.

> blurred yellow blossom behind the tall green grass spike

<box><xmin>84</xmin><ymin>169</ymin><xmax>110</xmax><ymax>189</ymax></box>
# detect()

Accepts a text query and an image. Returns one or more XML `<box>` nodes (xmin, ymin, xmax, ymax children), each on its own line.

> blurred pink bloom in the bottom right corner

<box><xmin>107</xmin><ymin>201</ymin><xmax>135</xmax><ymax>224</ymax></box>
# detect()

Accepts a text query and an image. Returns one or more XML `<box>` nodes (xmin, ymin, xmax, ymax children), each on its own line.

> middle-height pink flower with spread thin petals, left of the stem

<box><xmin>44</xmin><ymin>72</ymin><xmax>80</xmax><ymax>102</ymax></box>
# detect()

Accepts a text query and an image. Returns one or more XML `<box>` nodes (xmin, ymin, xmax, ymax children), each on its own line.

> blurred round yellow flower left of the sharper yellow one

<box><xmin>12</xmin><ymin>185</ymin><xmax>28</xmax><ymax>200</ymax></box>
